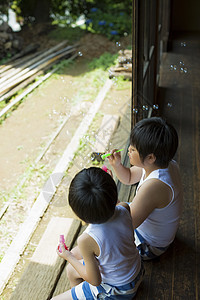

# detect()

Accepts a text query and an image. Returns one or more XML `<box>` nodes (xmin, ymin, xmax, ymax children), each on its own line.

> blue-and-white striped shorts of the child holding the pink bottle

<box><xmin>71</xmin><ymin>264</ymin><xmax>145</xmax><ymax>300</ymax></box>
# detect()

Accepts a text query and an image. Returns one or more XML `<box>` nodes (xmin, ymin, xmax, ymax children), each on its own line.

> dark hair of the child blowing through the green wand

<box><xmin>130</xmin><ymin>117</ymin><xmax>178</xmax><ymax>168</ymax></box>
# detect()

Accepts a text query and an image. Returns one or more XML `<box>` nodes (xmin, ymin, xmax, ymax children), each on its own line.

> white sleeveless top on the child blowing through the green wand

<box><xmin>136</xmin><ymin>161</ymin><xmax>183</xmax><ymax>247</ymax></box>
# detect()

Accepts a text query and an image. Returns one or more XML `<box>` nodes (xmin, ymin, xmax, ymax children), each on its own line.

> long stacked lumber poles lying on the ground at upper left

<box><xmin>0</xmin><ymin>41</ymin><xmax>77</xmax><ymax>116</ymax></box>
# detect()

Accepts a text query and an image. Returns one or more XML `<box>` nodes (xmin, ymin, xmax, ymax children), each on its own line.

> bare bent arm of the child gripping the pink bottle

<box><xmin>57</xmin><ymin>233</ymin><xmax>101</xmax><ymax>286</ymax></box>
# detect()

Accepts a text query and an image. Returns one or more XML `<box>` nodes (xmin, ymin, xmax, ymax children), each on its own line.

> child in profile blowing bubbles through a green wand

<box><xmin>108</xmin><ymin>117</ymin><xmax>183</xmax><ymax>259</ymax></box>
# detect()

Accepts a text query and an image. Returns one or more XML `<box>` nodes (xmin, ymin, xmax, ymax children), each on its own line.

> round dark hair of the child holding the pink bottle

<box><xmin>69</xmin><ymin>167</ymin><xmax>118</xmax><ymax>224</ymax></box>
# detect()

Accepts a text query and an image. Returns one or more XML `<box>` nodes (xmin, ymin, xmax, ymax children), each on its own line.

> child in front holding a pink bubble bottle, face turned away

<box><xmin>53</xmin><ymin>167</ymin><xmax>144</xmax><ymax>300</ymax></box>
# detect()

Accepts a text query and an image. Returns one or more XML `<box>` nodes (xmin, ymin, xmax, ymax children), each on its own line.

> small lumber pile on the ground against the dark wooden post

<box><xmin>109</xmin><ymin>50</ymin><xmax>132</xmax><ymax>80</ymax></box>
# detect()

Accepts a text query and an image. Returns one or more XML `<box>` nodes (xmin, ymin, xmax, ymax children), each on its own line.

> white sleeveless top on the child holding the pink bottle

<box><xmin>85</xmin><ymin>205</ymin><xmax>141</xmax><ymax>286</ymax></box>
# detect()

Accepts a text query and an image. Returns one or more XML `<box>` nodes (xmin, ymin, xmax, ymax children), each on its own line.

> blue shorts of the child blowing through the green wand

<box><xmin>134</xmin><ymin>229</ymin><xmax>169</xmax><ymax>260</ymax></box>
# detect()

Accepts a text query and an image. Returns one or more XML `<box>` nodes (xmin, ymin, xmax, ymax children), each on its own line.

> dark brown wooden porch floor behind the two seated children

<box><xmin>136</xmin><ymin>33</ymin><xmax>200</xmax><ymax>300</ymax></box>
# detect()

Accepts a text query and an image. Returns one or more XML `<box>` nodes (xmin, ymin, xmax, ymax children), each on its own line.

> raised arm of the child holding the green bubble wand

<box><xmin>107</xmin><ymin>150</ymin><xmax>142</xmax><ymax>185</ymax></box>
